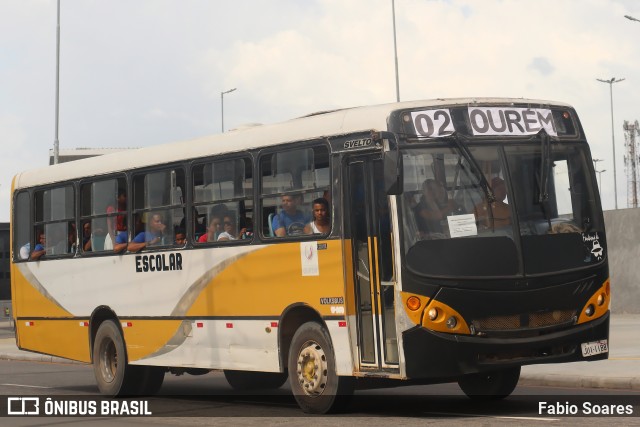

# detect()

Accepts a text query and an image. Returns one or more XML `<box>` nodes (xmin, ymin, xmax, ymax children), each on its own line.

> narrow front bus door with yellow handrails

<box><xmin>343</xmin><ymin>156</ymin><xmax>398</xmax><ymax>371</ymax></box>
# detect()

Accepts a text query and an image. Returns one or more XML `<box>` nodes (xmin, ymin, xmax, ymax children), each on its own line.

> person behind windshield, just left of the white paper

<box><xmin>413</xmin><ymin>178</ymin><xmax>462</xmax><ymax>239</ymax></box>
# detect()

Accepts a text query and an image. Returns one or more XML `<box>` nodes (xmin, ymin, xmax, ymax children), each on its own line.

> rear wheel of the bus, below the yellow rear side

<box><xmin>93</xmin><ymin>320</ymin><xmax>144</xmax><ymax>396</ymax></box>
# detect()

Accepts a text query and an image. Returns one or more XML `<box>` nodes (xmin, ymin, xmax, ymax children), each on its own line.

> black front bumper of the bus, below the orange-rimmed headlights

<box><xmin>403</xmin><ymin>312</ymin><xmax>609</xmax><ymax>379</ymax></box>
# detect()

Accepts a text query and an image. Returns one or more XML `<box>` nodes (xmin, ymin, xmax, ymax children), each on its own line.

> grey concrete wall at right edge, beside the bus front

<box><xmin>604</xmin><ymin>209</ymin><xmax>640</xmax><ymax>314</ymax></box>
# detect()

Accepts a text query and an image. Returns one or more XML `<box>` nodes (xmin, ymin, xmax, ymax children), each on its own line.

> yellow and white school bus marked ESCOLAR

<box><xmin>11</xmin><ymin>98</ymin><xmax>610</xmax><ymax>413</ymax></box>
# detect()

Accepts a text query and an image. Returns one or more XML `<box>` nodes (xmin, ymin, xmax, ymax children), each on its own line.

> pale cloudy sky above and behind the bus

<box><xmin>0</xmin><ymin>0</ymin><xmax>640</xmax><ymax>222</ymax></box>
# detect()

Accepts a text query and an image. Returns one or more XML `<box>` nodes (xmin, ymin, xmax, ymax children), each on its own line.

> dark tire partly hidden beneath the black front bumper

<box><xmin>458</xmin><ymin>366</ymin><xmax>520</xmax><ymax>400</ymax></box>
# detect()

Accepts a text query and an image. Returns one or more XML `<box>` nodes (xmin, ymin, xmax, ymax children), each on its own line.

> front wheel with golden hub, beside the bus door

<box><xmin>288</xmin><ymin>322</ymin><xmax>354</xmax><ymax>414</ymax></box>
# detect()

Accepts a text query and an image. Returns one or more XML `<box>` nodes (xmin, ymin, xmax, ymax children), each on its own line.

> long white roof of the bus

<box><xmin>13</xmin><ymin>98</ymin><xmax>571</xmax><ymax>189</ymax></box>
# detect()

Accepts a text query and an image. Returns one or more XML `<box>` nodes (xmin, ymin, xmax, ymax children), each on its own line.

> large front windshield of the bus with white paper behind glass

<box><xmin>400</xmin><ymin>139</ymin><xmax>606</xmax><ymax>277</ymax></box>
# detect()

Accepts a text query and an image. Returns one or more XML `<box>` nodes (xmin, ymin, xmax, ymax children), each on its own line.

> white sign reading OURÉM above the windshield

<box><xmin>468</xmin><ymin>107</ymin><xmax>558</xmax><ymax>136</ymax></box>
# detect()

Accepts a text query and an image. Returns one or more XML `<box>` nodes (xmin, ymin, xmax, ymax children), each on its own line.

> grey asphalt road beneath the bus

<box><xmin>0</xmin><ymin>361</ymin><xmax>640</xmax><ymax>427</ymax></box>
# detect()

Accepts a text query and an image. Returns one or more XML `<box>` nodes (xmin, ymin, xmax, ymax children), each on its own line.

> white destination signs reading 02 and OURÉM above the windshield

<box><xmin>411</xmin><ymin>107</ymin><xmax>558</xmax><ymax>138</ymax></box>
